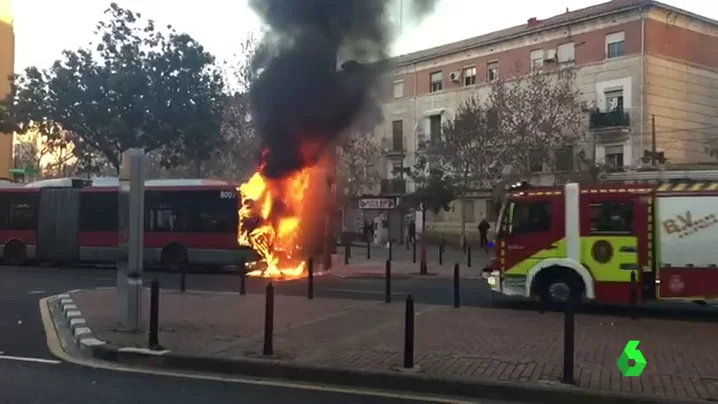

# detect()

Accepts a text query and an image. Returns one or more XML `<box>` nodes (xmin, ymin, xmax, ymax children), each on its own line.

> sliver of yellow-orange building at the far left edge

<box><xmin>0</xmin><ymin>0</ymin><xmax>15</xmax><ymax>179</ymax></box>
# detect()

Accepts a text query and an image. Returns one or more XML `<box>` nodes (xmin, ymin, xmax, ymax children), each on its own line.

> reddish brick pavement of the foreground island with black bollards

<box><xmin>73</xmin><ymin>290</ymin><xmax>718</xmax><ymax>400</ymax></box>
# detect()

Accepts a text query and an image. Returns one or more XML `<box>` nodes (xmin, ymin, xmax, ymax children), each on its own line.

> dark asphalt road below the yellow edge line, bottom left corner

<box><xmin>0</xmin><ymin>360</ymin><xmax>517</xmax><ymax>404</ymax></box>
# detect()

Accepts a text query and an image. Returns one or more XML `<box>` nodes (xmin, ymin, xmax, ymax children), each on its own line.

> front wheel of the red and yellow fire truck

<box><xmin>536</xmin><ymin>267</ymin><xmax>584</xmax><ymax>304</ymax></box>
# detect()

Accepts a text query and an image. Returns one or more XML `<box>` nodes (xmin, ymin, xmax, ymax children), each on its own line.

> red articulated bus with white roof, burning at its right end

<box><xmin>0</xmin><ymin>178</ymin><xmax>254</xmax><ymax>270</ymax></box>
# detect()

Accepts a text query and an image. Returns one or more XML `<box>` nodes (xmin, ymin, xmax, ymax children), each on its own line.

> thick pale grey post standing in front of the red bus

<box><xmin>117</xmin><ymin>149</ymin><xmax>145</xmax><ymax>332</ymax></box>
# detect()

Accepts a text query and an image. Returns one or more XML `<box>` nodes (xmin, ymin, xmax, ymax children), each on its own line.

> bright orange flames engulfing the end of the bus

<box><xmin>237</xmin><ymin>167</ymin><xmax>310</xmax><ymax>279</ymax></box>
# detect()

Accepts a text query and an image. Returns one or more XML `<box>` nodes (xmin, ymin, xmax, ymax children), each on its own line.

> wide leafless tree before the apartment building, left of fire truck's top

<box><xmin>434</xmin><ymin>65</ymin><xmax>589</xmax><ymax>221</ymax></box>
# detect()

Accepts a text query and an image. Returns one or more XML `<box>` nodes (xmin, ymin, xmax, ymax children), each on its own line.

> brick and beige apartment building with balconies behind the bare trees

<box><xmin>368</xmin><ymin>0</ymin><xmax>718</xmax><ymax>240</ymax></box>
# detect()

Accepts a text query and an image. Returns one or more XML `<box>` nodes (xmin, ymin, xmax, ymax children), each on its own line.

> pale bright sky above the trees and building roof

<box><xmin>9</xmin><ymin>0</ymin><xmax>718</xmax><ymax>72</ymax></box>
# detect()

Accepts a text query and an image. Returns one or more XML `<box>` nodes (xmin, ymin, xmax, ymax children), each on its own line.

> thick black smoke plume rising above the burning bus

<box><xmin>250</xmin><ymin>0</ymin><xmax>436</xmax><ymax>178</ymax></box>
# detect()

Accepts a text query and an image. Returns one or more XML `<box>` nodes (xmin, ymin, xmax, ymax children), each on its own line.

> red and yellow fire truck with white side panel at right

<box><xmin>484</xmin><ymin>172</ymin><xmax>718</xmax><ymax>304</ymax></box>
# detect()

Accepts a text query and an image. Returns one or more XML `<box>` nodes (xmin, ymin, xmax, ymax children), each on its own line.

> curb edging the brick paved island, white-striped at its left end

<box><xmin>49</xmin><ymin>293</ymin><xmax>707</xmax><ymax>404</ymax></box>
